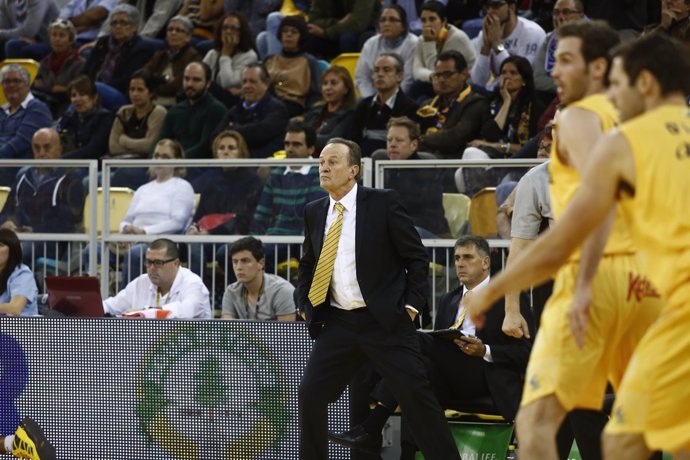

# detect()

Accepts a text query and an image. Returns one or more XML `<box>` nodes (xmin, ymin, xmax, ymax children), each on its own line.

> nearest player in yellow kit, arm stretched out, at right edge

<box><xmin>469</xmin><ymin>34</ymin><xmax>690</xmax><ymax>460</ymax></box>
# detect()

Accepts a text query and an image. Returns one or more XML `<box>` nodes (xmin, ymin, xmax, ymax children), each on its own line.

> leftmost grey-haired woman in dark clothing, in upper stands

<box><xmin>32</xmin><ymin>19</ymin><xmax>84</xmax><ymax>119</ymax></box>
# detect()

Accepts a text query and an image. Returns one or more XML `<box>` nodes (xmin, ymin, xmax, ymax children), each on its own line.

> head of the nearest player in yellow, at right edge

<box><xmin>609</xmin><ymin>33</ymin><xmax>690</xmax><ymax>122</ymax></box>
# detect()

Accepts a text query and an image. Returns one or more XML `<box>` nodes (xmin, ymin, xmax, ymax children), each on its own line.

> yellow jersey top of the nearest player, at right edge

<box><xmin>620</xmin><ymin>105</ymin><xmax>690</xmax><ymax>299</ymax></box>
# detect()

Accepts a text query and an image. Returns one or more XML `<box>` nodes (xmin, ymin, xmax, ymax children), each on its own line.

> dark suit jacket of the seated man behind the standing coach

<box><xmin>434</xmin><ymin>286</ymin><xmax>534</xmax><ymax>420</ymax></box>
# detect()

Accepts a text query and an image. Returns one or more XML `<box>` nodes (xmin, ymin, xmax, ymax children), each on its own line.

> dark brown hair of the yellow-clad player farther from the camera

<box><xmin>556</xmin><ymin>21</ymin><xmax>620</xmax><ymax>86</ymax></box>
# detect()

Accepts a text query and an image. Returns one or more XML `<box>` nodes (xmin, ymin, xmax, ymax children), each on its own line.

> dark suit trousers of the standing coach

<box><xmin>299</xmin><ymin>308</ymin><xmax>460</xmax><ymax>460</ymax></box>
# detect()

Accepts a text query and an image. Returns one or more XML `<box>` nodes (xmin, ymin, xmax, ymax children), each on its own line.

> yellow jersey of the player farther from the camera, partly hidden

<box><xmin>549</xmin><ymin>94</ymin><xmax>635</xmax><ymax>261</ymax></box>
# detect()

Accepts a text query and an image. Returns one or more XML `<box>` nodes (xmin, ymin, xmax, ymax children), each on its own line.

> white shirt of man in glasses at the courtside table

<box><xmin>103</xmin><ymin>267</ymin><xmax>213</xmax><ymax>319</ymax></box>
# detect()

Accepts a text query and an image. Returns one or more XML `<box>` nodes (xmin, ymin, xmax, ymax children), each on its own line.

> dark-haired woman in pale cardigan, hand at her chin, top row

<box><xmin>408</xmin><ymin>0</ymin><xmax>477</xmax><ymax>100</ymax></box>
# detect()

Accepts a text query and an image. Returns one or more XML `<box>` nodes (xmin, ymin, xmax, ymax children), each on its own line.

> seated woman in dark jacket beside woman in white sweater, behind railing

<box><xmin>187</xmin><ymin>127</ymin><xmax>263</xmax><ymax>274</ymax></box>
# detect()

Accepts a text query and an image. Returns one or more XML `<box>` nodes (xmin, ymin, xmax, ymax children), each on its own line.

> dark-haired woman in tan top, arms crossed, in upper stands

<box><xmin>264</xmin><ymin>15</ymin><xmax>321</xmax><ymax>117</ymax></box>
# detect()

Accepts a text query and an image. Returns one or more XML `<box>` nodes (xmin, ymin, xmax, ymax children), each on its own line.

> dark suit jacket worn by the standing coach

<box><xmin>297</xmin><ymin>187</ymin><xmax>429</xmax><ymax>338</ymax></box>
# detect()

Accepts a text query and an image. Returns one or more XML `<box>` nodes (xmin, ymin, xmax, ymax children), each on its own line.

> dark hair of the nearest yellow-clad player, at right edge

<box><xmin>612</xmin><ymin>33</ymin><xmax>690</xmax><ymax>96</ymax></box>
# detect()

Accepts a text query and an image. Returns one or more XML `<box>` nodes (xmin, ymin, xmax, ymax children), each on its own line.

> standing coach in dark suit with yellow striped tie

<box><xmin>297</xmin><ymin>138</ymin><xmax>460</xmax><ymax>460</ymax></box>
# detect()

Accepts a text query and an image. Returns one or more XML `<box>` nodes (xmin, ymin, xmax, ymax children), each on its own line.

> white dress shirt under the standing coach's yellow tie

<box><xmin>324</xmin><ymin>184</ymin><xmax>366</xmax><ymax>310</ymax></box>
